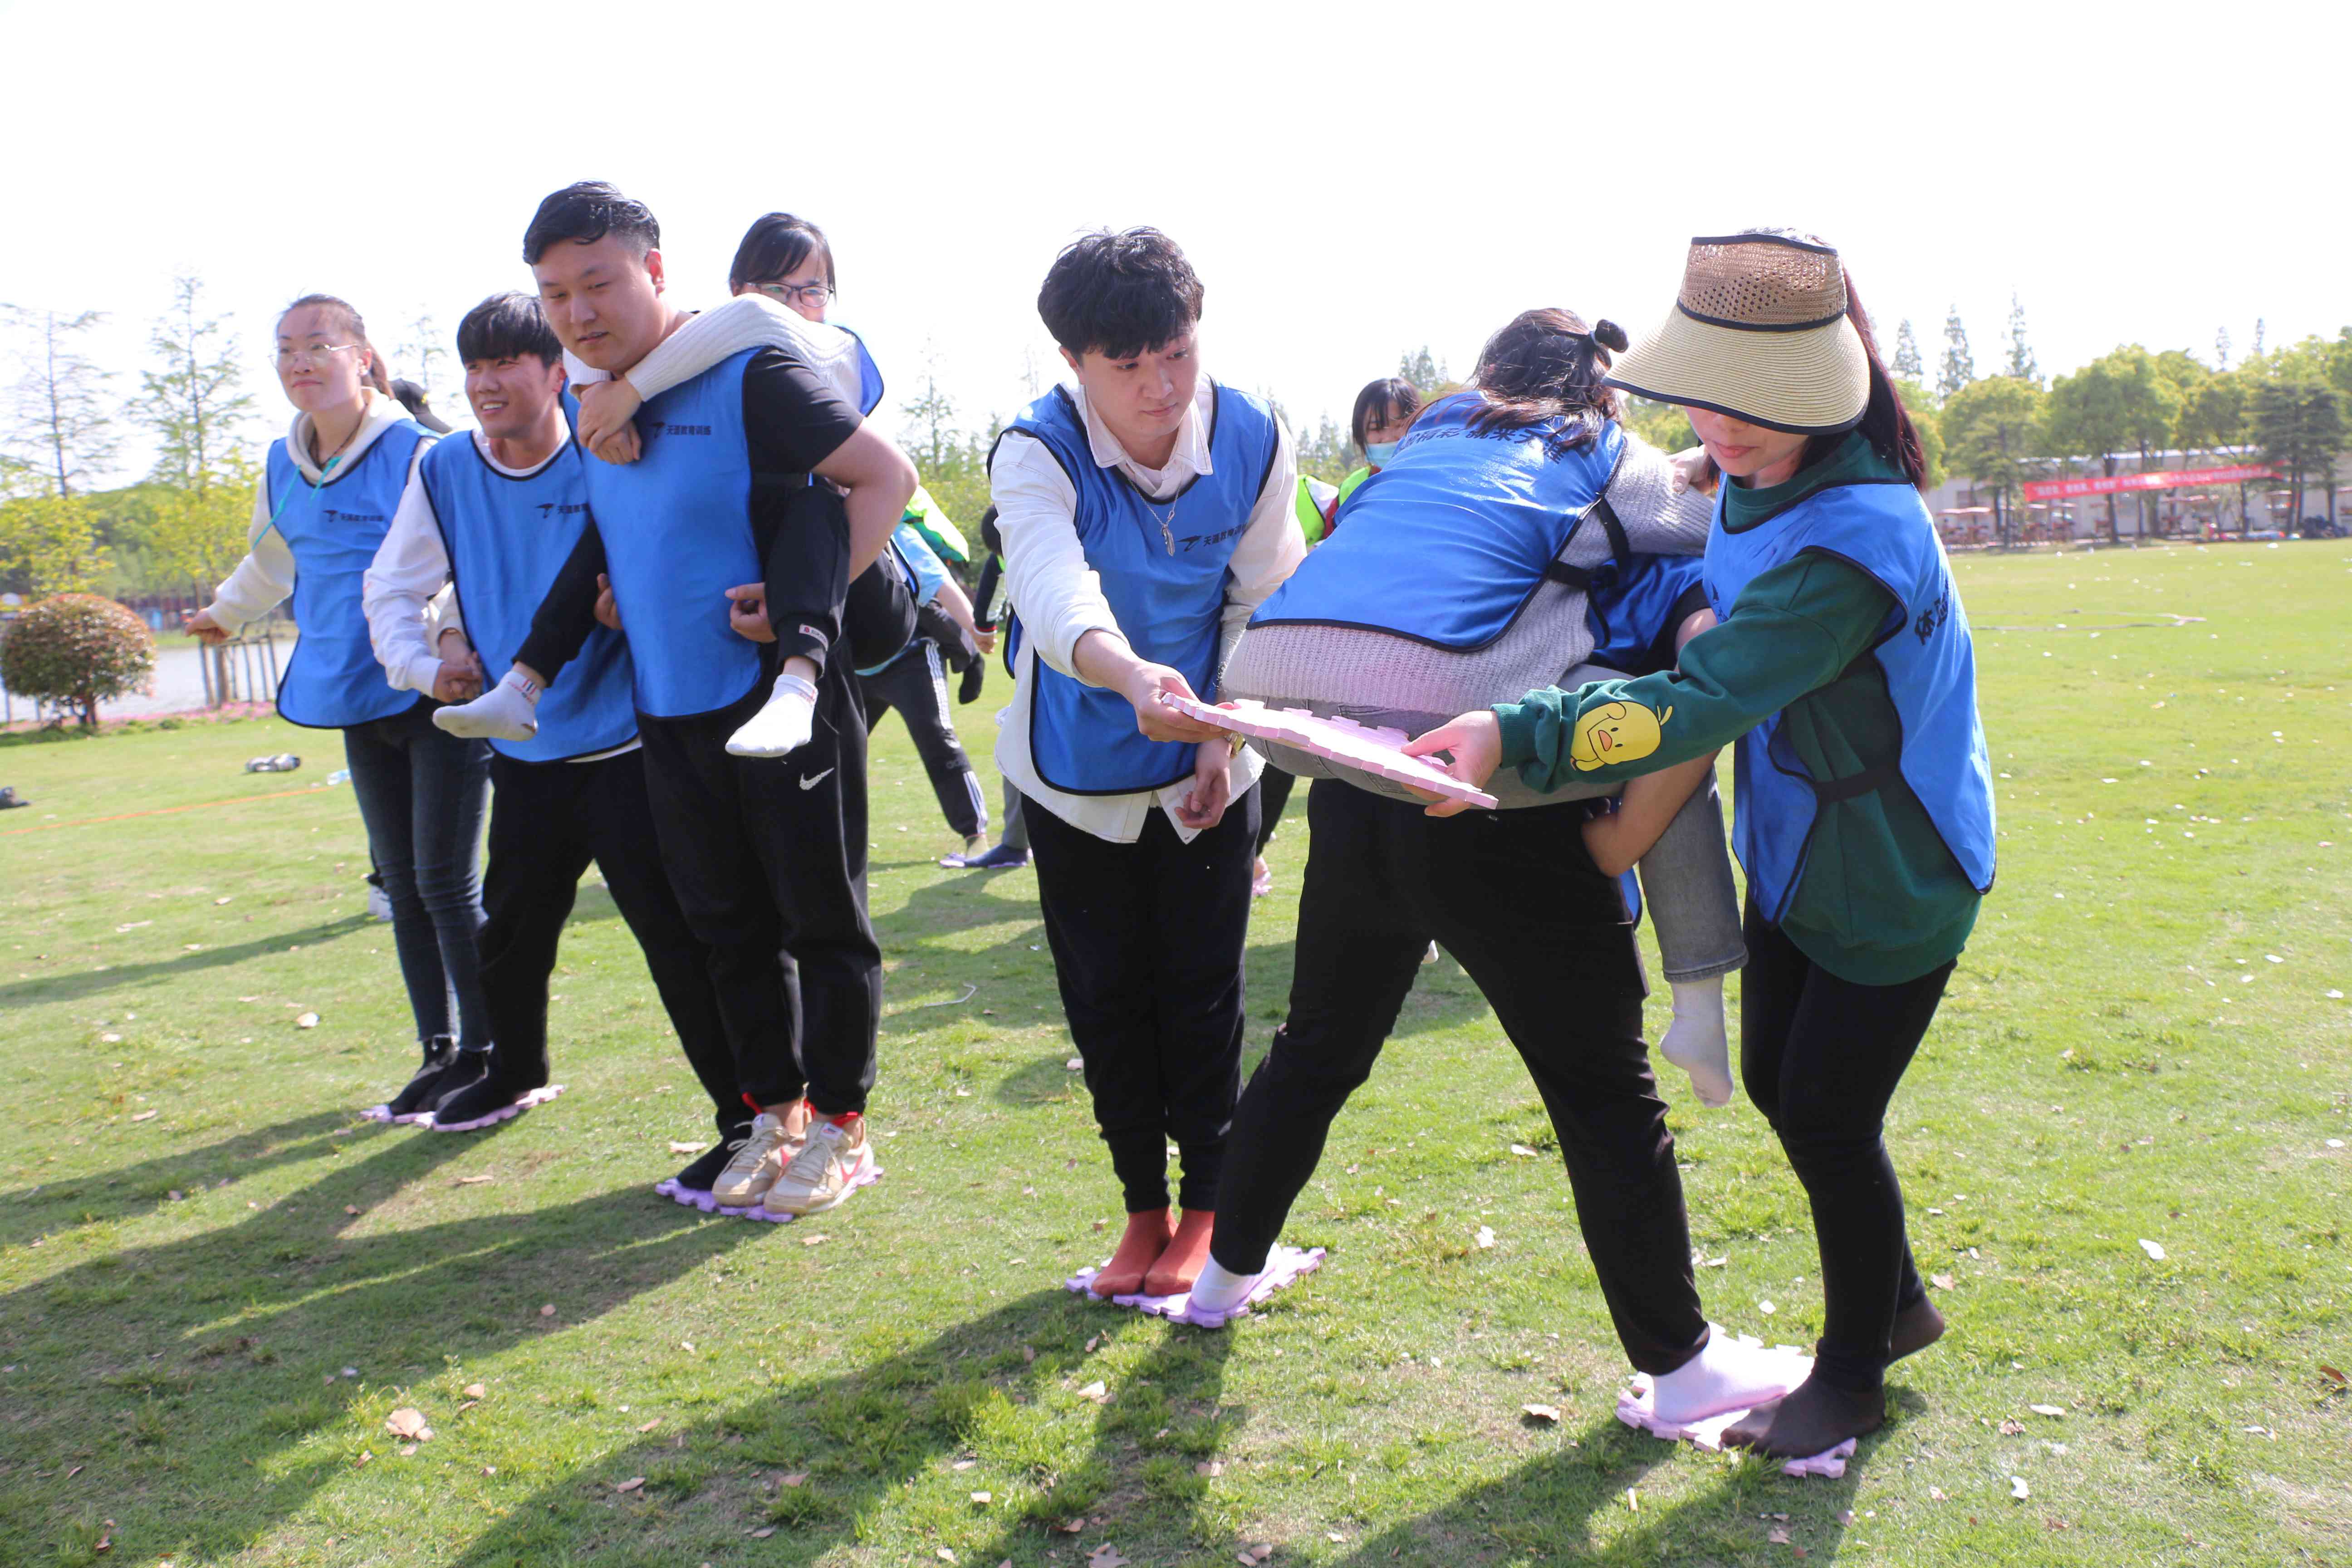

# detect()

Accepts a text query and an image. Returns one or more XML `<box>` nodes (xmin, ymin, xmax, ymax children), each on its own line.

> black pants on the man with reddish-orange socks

<box><xmin>1021</xmin><ymin>790</ymin><xmax>1258</xmax><ymax>1213</ymax></box>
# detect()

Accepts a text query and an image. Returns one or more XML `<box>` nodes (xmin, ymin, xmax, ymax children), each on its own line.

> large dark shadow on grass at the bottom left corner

<box><xmin>0</xmin><ymin>1124</ymin><xmax>764</xmax><ymax>1558</ymax></box>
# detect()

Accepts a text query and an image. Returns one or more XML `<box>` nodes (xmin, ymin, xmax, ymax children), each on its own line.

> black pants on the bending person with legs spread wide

<box><xmin>1211</xmin><ymin>780</ymin><xmax>1708</xmax><ymax>1373</ymax></box>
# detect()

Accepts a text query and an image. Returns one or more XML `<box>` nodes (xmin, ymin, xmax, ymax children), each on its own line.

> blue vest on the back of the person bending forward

<box><xmin>1249</xmin><ymin>392</ymin><xmax>1625</xmax><ymax>651</ymax></box>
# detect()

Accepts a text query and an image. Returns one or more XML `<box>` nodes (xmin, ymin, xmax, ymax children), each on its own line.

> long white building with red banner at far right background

<box><xmin>1926</xmin><ymin>446</ymin><xmax>2352</xmax><ymax>543</ymax></box>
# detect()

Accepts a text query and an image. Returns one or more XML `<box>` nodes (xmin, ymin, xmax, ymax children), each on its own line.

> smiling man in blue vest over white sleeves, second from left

<box><xmin>365</xmin><ymin>294</ymin><xmax>750</xmax><ymax>1152</ymax></box>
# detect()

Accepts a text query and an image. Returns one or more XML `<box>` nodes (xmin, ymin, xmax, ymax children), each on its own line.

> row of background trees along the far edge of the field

<box><xmin>0</xmin><ymin>285</ymin><xmax>2352</xmax><ymax>616</ymax></box>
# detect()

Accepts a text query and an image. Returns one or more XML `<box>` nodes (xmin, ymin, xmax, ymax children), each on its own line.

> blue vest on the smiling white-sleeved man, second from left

<box><xmin>416</xmin><ymin>435</ymin><xmax>637</xmax><ymax>762</ymax></box>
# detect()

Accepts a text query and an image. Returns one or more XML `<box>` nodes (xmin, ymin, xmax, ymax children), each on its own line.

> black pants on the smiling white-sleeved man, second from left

<box><xmin>477</xmin><ymin>752</ymin><xmax>743</xmax><ymax>1128</ymax></box>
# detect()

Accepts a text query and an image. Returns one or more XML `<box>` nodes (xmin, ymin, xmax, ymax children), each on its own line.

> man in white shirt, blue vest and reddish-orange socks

<box><xmin>988</xmin><ymin>228</ymin><xmax>1305</xmax><ymax>1295</ymax></box>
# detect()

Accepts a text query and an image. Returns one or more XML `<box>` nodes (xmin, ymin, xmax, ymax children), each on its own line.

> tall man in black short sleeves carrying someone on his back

<box><xmin>437</xmin><ymin>181</ymin><xmax>915</xmax><ymax>1220</ymax></box>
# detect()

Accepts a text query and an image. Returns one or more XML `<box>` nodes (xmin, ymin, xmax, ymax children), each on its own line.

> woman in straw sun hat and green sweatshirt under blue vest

<box><xmin>1411</xmin><ymin>230</ymin><xmax>1994</xmax><ymax>1455</ymax></box>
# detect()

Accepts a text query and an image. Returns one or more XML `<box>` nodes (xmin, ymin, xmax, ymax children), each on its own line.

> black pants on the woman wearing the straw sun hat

<box><xmin>1740</xmin><ymin>900</ymin><xmax>1952</xmax><ymax>1392</ymax></box>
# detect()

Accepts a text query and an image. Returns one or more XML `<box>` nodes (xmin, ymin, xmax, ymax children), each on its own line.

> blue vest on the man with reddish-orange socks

<box><xmin>997</xmin><ymin>386</ymin><xmax>1282</xmax><ymax>794</ymax></box>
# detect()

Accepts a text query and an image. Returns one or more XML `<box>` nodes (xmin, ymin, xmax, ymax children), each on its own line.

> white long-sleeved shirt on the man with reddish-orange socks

<box><xmin>988</xmin><ymin>376</ymin><xmax>1308</xmax><ymax>844</ymax></box>
